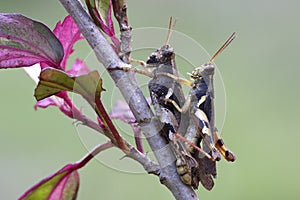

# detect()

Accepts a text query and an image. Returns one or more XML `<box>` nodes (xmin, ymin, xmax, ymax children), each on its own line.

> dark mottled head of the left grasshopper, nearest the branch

<box><xmin>146</xmin><ymin>45</ymin><xmax>175</xmax><ymax>67</ymax></box>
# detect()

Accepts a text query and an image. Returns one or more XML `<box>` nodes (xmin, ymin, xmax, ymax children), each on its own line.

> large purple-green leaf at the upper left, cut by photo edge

<box><xmin>0</xmin><ymin>14</ymin><xmax>64</xmax><ymax>68</ymax></box>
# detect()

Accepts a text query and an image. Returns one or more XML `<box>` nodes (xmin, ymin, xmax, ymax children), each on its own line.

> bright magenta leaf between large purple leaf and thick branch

<box><xmin>53</xmin><ymin>16</ymin><xmax>83</xmax><ymax>70</ymax></box>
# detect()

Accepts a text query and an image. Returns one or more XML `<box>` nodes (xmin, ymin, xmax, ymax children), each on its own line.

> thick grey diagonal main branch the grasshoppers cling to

<box><xmin>60</xmin><ymin>0</ymin><xmax>198</xmax><ymax>200</ymax></box>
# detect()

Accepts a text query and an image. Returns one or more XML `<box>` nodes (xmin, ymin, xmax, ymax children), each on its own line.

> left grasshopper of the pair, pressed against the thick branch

<box><xmin>146</xmin><ymin>18</ymin><xmax>204</xmax><ymax>188</ymax></box>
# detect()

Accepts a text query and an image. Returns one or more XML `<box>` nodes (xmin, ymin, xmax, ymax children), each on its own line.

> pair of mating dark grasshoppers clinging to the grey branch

<box><xmin>123</xmin><ymin>18</ymin><xmax>235</xmax><ymax>190</ymax></box>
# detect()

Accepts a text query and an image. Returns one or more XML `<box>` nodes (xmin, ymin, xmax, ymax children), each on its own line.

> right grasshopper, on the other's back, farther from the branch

<box><xmin>157</xmin><ymin>33</ymin><xmax>236</xmax><ymax>190</ymax></box>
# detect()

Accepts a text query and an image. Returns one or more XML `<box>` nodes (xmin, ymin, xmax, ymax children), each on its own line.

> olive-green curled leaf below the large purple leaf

<box><xmin>34</xmin><ymin>68</ymin><xmax>104</xmax><ymax>102</ymax></box>
